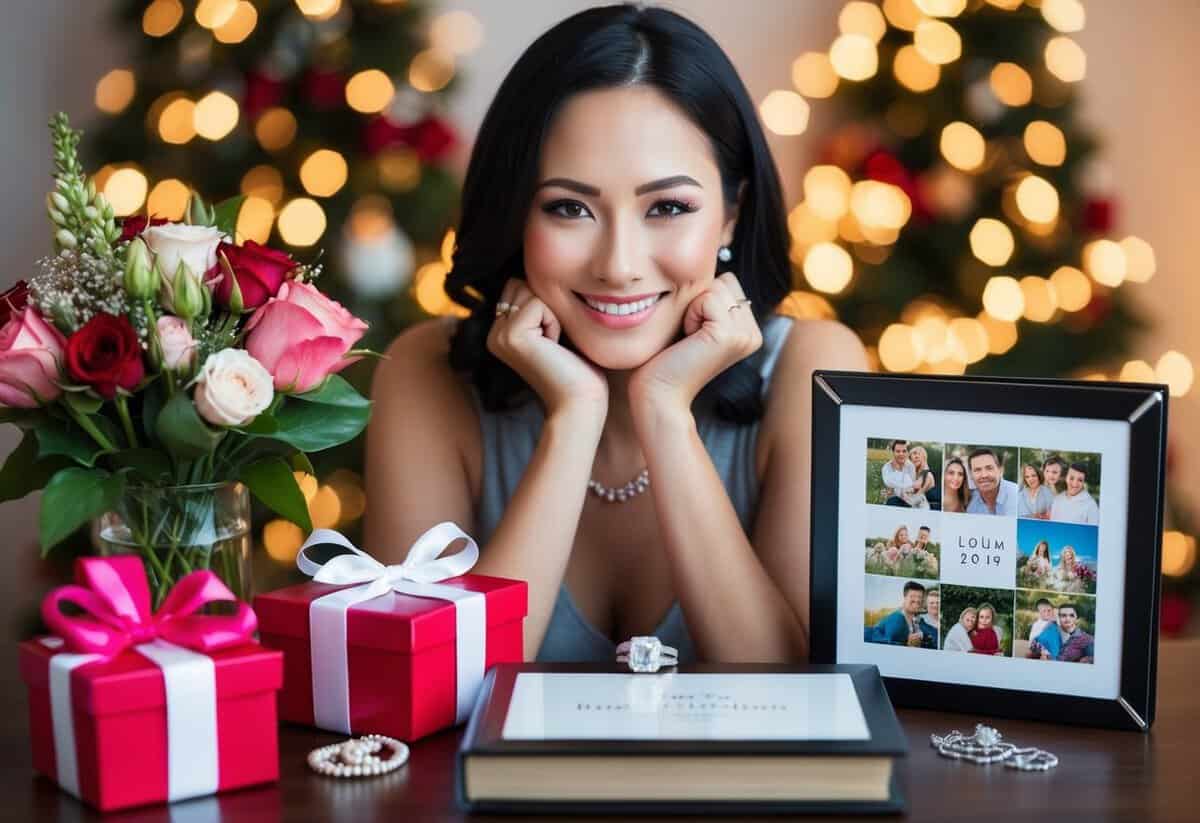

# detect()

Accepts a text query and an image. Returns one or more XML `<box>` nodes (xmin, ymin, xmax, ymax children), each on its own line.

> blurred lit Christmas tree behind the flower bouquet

<box><xmin>85</xmin><ymin>0</ymin><xmax>470</xmax><ymax>560</ymax></box>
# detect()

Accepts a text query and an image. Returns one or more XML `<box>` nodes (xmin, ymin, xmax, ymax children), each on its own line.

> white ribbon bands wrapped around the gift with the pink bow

<box><xmin>42</xmin><ymin>637</ymin><xmax>220</xmax><ymax>803</ymax></box>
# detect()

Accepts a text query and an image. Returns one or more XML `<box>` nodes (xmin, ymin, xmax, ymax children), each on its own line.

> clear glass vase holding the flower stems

<box><xmin>96</xmin><ymin>482</ymin><xmax>254</xmax><ymax>612</ymax></box>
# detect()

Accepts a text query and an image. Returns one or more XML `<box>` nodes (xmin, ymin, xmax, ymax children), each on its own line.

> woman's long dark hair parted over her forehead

<box><xmin>445</xmin><ymin>4</ymin><xmax>791</xmax><ymax>422</ymax></box>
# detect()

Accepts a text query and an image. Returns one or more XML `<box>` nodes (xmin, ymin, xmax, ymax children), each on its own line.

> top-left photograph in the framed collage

<box><xmin>866</xmin><ymin>437</ymin><xmax>942</xmax><ymax>509</ymax></box>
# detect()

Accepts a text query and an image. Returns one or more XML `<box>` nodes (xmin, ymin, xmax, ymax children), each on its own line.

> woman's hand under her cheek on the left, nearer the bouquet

<box><xmin>487</xmin><ymin>278</ymin><xmax>608</xmax><ymax>422</ymax></box>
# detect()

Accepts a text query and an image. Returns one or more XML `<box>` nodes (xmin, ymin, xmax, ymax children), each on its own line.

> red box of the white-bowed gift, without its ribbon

<box><xmin>254</xmin><ymin>575</ymin><xmax>528</xmax><ymax>740</ymax></box>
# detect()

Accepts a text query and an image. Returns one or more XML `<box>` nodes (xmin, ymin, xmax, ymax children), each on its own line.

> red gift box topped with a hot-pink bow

<box><xmin>19</xmin><ymin>557</ymin><xmax>283</xmax><ymax>811</ymax></box>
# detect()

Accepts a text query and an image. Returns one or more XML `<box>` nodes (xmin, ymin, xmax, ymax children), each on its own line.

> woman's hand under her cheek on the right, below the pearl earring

<box><xmin>629</xmin><ymin>272</ymin><xmax>762</xmax><ymax>414</ymax></box>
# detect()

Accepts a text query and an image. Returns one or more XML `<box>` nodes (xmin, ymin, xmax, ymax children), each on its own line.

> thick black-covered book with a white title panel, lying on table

<box><xmin>456</xmin><ymin>663</ymin><xmax>908</xmax><ymax>815</ymax></box>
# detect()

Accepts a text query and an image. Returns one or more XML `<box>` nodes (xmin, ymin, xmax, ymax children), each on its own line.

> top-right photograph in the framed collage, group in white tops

<box><xmin>1016</xmin><ymin>449</ymin><xmax>1100</xmax><ymax>525</ymax></box>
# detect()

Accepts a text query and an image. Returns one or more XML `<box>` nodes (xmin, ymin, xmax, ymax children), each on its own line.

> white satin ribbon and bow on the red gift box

<box><xmin>296</xmin><ymin>523</ymin><xmax>487</xmax><ymax>734</ymax></box>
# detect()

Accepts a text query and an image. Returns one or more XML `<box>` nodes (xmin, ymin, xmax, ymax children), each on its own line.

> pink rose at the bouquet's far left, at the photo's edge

<box><xmin>0</xmin><ymin>308</ymin><xmax>67</xmax><ymax>409</ymax></box>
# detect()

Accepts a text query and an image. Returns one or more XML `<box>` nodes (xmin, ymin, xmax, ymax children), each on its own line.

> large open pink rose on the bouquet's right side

<box><xmin>246</xmin><ymin>281</ymin><xmax>367</xmax><ymax>394</ymax></box>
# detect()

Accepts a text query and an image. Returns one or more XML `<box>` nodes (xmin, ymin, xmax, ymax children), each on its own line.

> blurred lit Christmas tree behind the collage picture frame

<box><xmin>762</xmin><ymin>0</ymin><xmax>1200</xmax><ymax>630</ymax></box>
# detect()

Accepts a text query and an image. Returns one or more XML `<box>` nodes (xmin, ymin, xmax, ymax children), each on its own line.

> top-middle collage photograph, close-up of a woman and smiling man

<box><xmin>942</xmin><ymin>444</ymin><xmax>1019</xmax><ymax>517</ymax></box>
